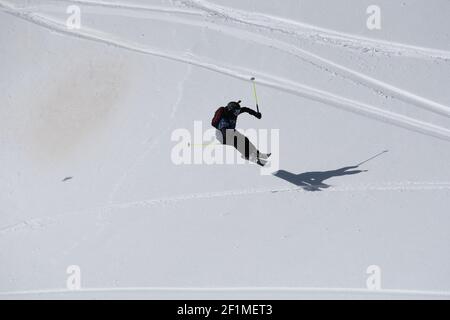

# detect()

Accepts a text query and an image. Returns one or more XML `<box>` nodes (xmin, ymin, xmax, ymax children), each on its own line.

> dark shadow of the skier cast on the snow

<box><xmin>273</xmin><ymin>166</ymin><xmax>367</xmax><ymax>191</ymax></box>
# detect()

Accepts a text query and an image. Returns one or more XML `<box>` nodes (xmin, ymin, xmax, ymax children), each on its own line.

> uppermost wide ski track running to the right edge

<box><xmin>180</xmin><ymin>0</ymin><xmax>450</xmax><ymax>60</ymax></box>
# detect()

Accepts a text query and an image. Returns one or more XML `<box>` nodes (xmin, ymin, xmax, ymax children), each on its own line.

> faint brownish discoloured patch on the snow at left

<box><xmin>31</xmin><ymin>53</ymin><xmax>127</xmax><ymax>161</ymax></box>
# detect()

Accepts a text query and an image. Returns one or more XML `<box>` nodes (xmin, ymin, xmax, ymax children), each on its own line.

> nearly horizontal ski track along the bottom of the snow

<box><xmin>0</xmin><ymin>286</ymin><xmax>450</xmax><ymax>300</ymax></box>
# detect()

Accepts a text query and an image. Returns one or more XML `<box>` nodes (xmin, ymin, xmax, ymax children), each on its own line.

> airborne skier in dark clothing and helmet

<box><xmin>211</xmin><ymin>100</ymin><xmax>270</xmax><ymax>166</ymax></box>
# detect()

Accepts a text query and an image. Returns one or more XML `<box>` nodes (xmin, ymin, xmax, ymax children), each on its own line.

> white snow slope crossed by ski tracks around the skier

<box><xmin>0</xmin><ymin>0</ymin><xmax>450</xmax><ymax>299</ymax></box>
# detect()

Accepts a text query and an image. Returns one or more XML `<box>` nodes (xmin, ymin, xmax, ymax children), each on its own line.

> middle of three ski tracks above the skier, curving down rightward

<box><xmin>57</xmin><ymin>0</ymin><xmax>450</xmax><ymax>117</ymax></box>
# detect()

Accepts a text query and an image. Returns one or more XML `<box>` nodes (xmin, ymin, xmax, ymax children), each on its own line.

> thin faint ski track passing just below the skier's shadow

<box><xmin>0</xmin><ymin>181</ymin><xmax>450</xmax><ymax>236</ymax></box>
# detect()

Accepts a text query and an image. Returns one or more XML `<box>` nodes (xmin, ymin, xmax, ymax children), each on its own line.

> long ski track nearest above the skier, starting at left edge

<box><xmin>0</xmin><ymin>0</ymin><xmax>450</xmax><ymax>141</ymax></box>
